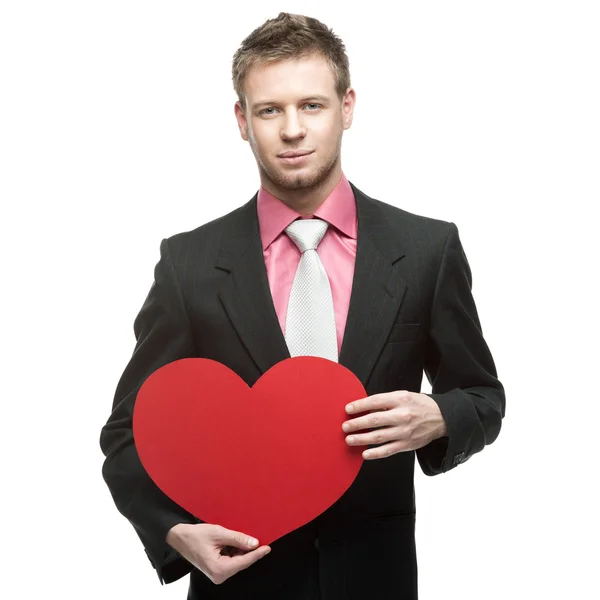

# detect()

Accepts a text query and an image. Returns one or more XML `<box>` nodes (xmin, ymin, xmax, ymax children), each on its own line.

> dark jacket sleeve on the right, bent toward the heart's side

<box><xmin>417</xmin><ymin>223</ymin><xmax>505</xmax><ymax>475</ymax></box>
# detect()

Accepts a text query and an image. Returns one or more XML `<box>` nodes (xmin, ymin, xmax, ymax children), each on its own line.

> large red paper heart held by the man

<box><xmin>133</xmin><ymin>356</ymin><xmax>367</xmax><ymax>544</ymax></box>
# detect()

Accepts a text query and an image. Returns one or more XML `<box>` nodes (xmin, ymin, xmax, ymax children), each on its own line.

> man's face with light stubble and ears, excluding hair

<box><xmin>235</xmin><ymin>55</ymin><xmax>355</xmax><ymax>193</ymax></box>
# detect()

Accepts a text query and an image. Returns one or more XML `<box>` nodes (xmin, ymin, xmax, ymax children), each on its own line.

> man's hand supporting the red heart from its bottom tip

<box><xmin>166</xmin><ymin>523</ymin><xmax>271</xmax><ymax>585</ymax></box>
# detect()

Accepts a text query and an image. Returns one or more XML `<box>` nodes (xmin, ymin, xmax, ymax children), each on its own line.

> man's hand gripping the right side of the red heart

<box><xmin>342</xmin><ymin>390</ymin><xmax>448</xmax><ymax>459</ymax></box>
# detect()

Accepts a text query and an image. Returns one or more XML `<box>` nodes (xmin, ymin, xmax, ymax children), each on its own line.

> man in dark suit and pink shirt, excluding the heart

<box><xmin>101</xmin><ymin>13</ymin><xmax>505</xmax><ymax>600</ymax></box>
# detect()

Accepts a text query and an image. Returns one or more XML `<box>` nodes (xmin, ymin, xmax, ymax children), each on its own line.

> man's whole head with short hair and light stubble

<box><xmin>232</xmin><ymin>13</ymin><xmax>355</xmax><ymax>206</ymax></box>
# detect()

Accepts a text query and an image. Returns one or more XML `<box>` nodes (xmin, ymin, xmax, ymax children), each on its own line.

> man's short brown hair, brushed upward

<box><xmin>232</xmin><ymin>12</ymin><xmax>350</xmax><ymax>109</ymax></box>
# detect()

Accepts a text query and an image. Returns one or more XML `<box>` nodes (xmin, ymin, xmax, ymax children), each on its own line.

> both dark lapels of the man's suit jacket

<box><xmin>215</xmin><ymin>183</ymin><xmax>406</xmax><ymax>386</ymax></box>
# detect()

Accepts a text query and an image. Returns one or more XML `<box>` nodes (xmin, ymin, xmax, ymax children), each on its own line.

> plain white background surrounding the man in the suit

<box><xmin>0</xmin><ymin>0</ymin><xmax>600</xmax><ymax>600</ymax></box>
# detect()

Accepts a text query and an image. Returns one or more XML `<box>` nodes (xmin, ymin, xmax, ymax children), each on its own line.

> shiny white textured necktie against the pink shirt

<box><xmin>285</xmin><ymin>219</ymin><xmax>338</xmax><ymax>362</ymax></box>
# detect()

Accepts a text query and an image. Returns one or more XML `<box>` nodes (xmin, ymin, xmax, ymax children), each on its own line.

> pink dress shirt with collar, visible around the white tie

<box><xmin>257</xmin><ymin>174</ymin><xmax>358</xmax><ymax>354</ymax></box>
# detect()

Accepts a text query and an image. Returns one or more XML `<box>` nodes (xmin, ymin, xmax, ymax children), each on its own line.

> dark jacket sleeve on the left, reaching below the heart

<box><xmin>100</xmin><ymin>240</ymin><xmax>199</xmax><ymax>584</ymax></box>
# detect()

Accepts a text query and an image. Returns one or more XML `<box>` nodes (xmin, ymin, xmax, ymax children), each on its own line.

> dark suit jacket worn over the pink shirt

<box><xmin>100</xmin><ymin>183</ymin><xmax>505</xmax><ymax>600</ymax></box>
